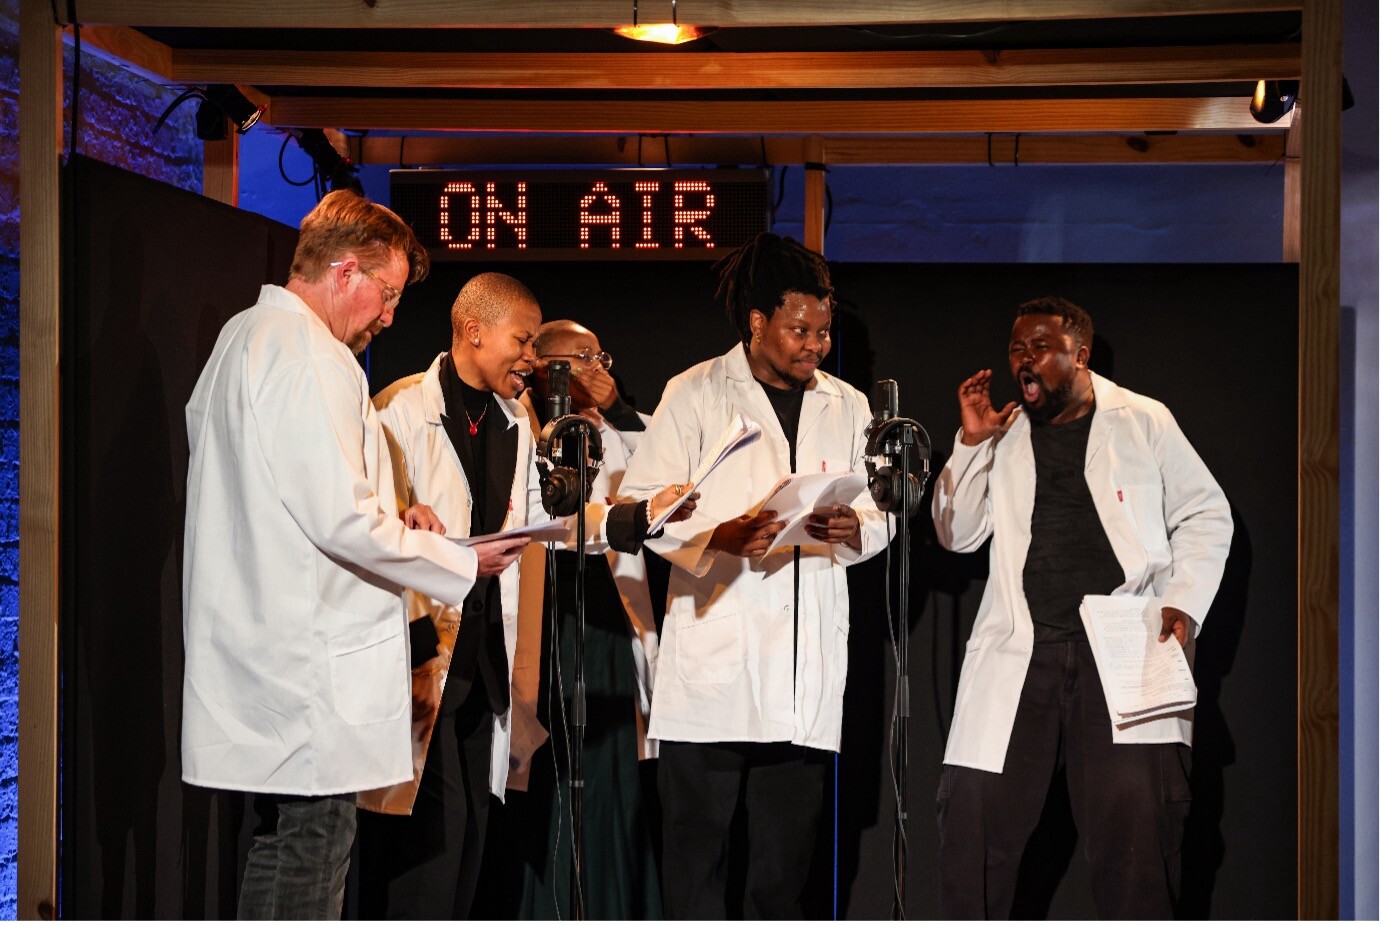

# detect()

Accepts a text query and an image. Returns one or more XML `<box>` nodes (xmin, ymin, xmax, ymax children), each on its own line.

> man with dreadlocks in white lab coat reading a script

<box><xmin>621</xmin><ymin>234</ymin><xmax>887</xmax><ymax>919</ymax></box>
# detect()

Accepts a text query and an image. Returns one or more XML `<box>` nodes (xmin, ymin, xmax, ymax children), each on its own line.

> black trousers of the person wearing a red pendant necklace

<box><xmin>360</xmin><ymin>683</ymin><xmax>494</xmax><ymax>919</ymax></box>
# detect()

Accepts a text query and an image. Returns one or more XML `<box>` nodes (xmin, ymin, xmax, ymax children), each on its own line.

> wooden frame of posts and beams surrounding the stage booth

<box><xmin>18</xmin><ymin>0</ymin><xmax>1341</xmax><ymax>918</ymax></box>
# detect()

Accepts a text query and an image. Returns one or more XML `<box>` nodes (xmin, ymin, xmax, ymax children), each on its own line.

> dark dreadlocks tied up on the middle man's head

<box><xmin>713</xmin><ymin>231</ymin><xmax>835</xmax><ymax>343</ymax></box>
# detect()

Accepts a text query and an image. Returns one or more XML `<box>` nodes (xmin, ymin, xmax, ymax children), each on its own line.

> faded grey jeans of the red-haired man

<box><xmin>237</xmin><ymin>793</ymin><xmax>356</xmax><ymax>919</ymax></box>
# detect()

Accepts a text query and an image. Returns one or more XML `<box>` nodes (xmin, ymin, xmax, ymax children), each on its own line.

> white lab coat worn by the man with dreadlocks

<box><xmin>623</xmin><ymin>343</ymin><xmax>887</xmax><ymax>751</ymax></box>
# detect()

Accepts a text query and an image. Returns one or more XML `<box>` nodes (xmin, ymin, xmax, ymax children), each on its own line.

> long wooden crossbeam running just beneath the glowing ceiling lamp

<box><xmin>172</xmin><ymin>44</ymin><xmax>1301</xmax><ymax>90</ymax></box>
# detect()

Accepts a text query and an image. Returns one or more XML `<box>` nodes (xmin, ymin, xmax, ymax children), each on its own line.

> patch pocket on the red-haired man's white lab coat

<box><xmin>327</xmin><ymin>622</ymin><xmax>408</xmax><ymax>726</ymax></box>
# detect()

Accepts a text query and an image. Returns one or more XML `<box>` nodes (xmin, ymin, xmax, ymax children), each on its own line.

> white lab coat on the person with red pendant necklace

<box><xmin>375</xmin><ymin>353</ymin><xmax>606</xmax><ymax>803</ymax></box>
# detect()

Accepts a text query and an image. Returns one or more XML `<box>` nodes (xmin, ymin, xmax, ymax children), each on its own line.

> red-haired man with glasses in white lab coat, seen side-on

<box><xmin>183</xmin><ymin>191</ymin><xmax>519</xmax><ymax>918</ymax></box>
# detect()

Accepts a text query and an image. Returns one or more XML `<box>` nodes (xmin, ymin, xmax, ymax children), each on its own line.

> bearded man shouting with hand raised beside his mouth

<box><xmin>933</xmin><ymin>298</ymin><xmax>1232</xmax><ymax>919</ymax></box>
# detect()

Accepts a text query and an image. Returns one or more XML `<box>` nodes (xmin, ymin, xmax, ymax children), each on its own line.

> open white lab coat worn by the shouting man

<box><xmin>933</xmin><ymin>374</ymin><xmax>1233</xmax><ymax>774</ymax></box>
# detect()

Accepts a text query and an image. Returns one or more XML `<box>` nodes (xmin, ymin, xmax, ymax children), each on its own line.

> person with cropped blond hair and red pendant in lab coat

<box><xmin>351</xmin><ymin>273</ymin><xmax>686</xmax><ymax>919</ymax></box>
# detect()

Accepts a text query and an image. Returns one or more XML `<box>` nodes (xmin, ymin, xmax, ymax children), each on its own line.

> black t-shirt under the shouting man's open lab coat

<box><xmin>1024</xmin><ymin>411</ymin><xmax>1124</xmax><ymax>643</ymax></box>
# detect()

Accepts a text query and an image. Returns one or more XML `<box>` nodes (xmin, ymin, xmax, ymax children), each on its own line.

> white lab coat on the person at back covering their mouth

<box><xmin>508</xmin><ymin>390</ymin><xmax>659</xmax><ymax>791</ymax></box>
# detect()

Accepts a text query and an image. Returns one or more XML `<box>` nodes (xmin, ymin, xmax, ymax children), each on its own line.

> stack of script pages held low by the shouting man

<box><xmin>1081</xmin><ymin>594</ymin><xmax>1197</xmax><ymax>726</ymax></box>
